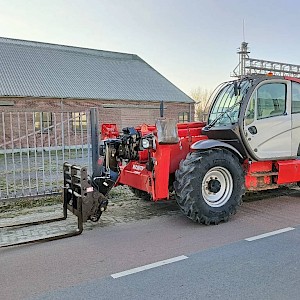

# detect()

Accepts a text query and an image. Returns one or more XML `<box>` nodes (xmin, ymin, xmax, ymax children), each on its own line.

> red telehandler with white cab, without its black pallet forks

<box><xmin>65</xmin><ymin>75</ymin><xmax>300</xmax><ymax>225</ymax></box>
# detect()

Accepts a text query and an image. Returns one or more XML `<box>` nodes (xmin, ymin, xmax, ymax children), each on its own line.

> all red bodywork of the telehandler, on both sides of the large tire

<box><xmin>101</xmin><ymin>122</ymin><xmax>300</xmax><ymax>201</ymax></box>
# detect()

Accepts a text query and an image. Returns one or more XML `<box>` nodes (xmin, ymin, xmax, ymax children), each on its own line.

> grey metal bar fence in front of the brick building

<box><xmin>0</xmin><ymin>111</ymin><xmax>91</xmax><ymax>201</ymax></box>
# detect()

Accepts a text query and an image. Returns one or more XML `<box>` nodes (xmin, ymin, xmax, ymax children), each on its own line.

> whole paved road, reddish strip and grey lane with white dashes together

<box><xmin>0</xmin><ymin>193</ymin><xmax>300</xmax><ymax>300</ymax></box>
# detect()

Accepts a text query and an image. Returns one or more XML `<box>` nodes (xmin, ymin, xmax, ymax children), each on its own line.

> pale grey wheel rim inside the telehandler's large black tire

<box><xmin>202</xmin><ymin>167</ymin><xmax>233</xmax><ymax>207</ymax></box>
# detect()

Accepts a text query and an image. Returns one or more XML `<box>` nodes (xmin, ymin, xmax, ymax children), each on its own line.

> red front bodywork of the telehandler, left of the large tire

<box><xmin>101</xmin><ymin>122</ymin><xmax>207</xmax><ymax>201</ymax></box>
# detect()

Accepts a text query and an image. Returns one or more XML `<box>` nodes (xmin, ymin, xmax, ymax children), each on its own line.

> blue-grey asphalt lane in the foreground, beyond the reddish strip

<box><xmin>35</xmin><ymin>227</ymin><xmax>300</xmax><ymax>300</ymax></box>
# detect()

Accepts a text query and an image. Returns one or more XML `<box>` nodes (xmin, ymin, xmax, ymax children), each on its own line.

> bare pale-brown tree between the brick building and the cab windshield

<box><xmin>190</xmin><ymin>87</ymin><xmax>212</xmax><ymax>121</ymax></box>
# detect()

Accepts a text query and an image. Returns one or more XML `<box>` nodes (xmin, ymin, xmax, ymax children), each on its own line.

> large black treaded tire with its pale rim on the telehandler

<box><xmin>174</xmin><ymin>149</ymin><xmax>245</xmax><ymax>225</ymax></box>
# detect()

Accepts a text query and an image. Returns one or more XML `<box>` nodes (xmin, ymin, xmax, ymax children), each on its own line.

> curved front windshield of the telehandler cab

<box><xmin>208</xmin><ymin>79</ymin><xmax>250</xmax><ymax>126</ymax></box>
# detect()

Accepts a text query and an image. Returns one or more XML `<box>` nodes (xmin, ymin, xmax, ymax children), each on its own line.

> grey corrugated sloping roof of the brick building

<box><xmin>0</xmin><ymin>37</ymin><xmax>193</xmax><ymax>103</ymax></box>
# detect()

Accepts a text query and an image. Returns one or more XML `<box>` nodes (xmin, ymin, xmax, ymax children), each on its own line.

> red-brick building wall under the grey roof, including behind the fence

<box><xmin>0</xmin><ymin>97</ymin><xmax>194</xmax><ymax>150</ymax></box>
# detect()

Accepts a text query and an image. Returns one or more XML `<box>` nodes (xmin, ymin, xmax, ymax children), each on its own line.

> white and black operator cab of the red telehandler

<box><xmin>204</xmin><ymin>76</ymin><xmax>300</xmax><ymax>161</ymax></box>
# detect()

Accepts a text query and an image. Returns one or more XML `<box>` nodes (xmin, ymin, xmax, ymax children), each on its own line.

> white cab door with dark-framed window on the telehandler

<box><xmin>243</xmin><ymin>79</ymin><xmax>292</xmax><ymax>160</ymax></box>
